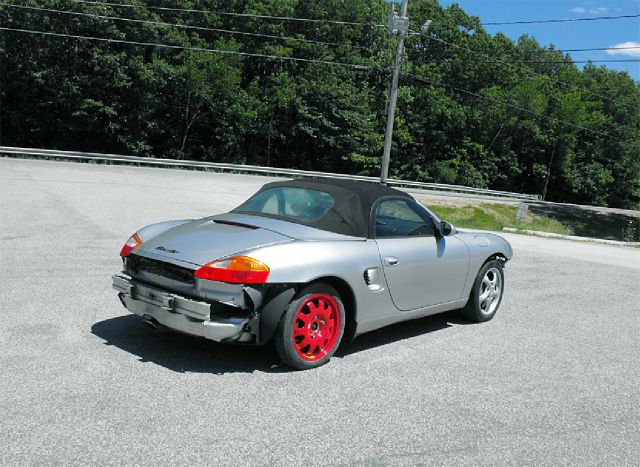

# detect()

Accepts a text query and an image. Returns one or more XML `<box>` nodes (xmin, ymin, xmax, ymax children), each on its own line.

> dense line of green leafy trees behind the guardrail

<box><xmin>0</xmin><ymin>0</ymin><xmax>640</xmax><ymax>208</ymax></box>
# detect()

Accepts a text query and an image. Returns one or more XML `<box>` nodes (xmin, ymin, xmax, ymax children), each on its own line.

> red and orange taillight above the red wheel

<box><xmin>194</xmin><ymin>256</ymin><xmax>269</xmax><ymax>284</ymax></box>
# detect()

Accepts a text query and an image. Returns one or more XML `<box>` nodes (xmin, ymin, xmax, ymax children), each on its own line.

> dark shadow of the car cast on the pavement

<box><xmin>91</xmin><ymin>312</ymin><xmax>468</xmax><ymax>374</ymax></box>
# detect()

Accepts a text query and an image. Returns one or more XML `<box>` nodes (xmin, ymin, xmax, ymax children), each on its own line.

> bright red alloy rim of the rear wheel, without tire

<box><xmin>292</xmin><ymin>293</ymin><xmax>340</xmax><ymax>361</ymax></box>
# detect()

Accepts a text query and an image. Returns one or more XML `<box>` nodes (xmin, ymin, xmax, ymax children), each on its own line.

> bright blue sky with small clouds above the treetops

<box><xmin>440</xmin><ymin>0</ymin><xmax>640</xmax><ymax>80</ymax></box>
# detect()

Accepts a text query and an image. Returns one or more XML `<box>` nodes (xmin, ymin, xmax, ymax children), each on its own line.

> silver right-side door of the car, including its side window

<box><xmin>372</xmin><ymin>197</ymin><xmax>469</xmax><ymax>311</ymax></box>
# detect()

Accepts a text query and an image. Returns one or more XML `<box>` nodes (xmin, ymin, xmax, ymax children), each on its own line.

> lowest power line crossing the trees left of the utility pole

<box><xmin>0</xmin><ymin>27</ymin><xmax>372</xmax><ymax>70</ymax></box>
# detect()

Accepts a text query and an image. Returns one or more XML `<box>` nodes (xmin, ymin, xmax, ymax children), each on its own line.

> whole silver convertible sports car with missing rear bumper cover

<box><xmin>113</xmin><ymin>179</ymin><xmax>512</xmax><ymax>369</ymax></box>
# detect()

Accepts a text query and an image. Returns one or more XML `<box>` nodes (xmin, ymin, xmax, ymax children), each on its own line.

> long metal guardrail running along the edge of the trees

<box><xmin>0</xmin><ymin>146</ymin><xmax>540</xmax><ymax>201</ymax></box>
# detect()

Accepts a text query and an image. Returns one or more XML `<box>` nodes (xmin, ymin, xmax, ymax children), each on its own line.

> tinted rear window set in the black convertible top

<box><xmin>235</xmin><ymin>187</ymin><xmax>334</xmax><ymax>222</ymax></box>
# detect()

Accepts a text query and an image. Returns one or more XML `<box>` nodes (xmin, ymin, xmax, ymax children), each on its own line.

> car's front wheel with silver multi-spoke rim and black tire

<box><xmin>462</xmin><ymin>260</ymin><xmax>504</xmax><ymax>323</ymax></box>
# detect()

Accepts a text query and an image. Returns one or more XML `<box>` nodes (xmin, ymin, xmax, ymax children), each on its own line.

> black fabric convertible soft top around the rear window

<box><xmin>234</xmin><ymin>178</ymin><xmax>411</xmax><ymax>238</ymax></box>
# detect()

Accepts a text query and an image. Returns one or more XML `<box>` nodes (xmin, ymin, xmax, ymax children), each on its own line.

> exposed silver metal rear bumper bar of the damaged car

<box><xmin>112</xmin><ymin>274</ymin><xmax>254</xmax><ymax>342</ymax></box>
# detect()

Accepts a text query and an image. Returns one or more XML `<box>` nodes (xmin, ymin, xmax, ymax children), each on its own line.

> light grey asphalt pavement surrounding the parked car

<box><xmin>0</xmin><ymin>158</ymin><xmax>640</xmax><ymax>465</ymax></box>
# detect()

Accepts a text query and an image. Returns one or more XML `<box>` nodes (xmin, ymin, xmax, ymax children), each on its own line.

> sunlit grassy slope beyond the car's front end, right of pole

<box><xmin>429</xmin><ymin>204</ymin><xmax>571</xmax><ymax>234</ymax></box>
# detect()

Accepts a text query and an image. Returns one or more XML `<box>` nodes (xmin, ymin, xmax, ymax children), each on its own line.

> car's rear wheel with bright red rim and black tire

<box><xmin>275</xmin><ymin>282</ymin><xmax>345</xmax><ymax>370</ymax></box>
